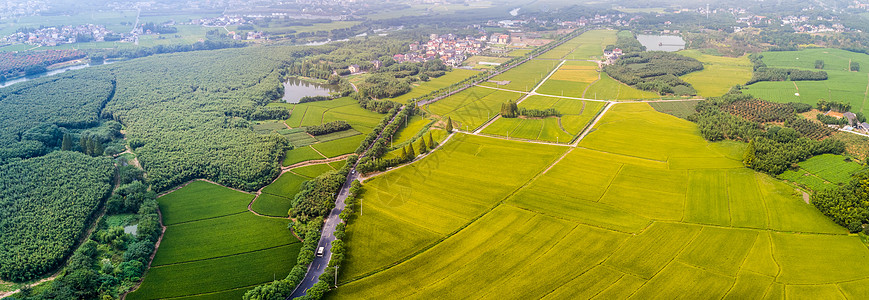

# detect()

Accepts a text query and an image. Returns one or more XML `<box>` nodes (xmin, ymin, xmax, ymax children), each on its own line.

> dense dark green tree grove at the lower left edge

<box><xmin>0</xmin><ymin>151</ymin><xmax>114</xmax><ymax>281</ymax></box>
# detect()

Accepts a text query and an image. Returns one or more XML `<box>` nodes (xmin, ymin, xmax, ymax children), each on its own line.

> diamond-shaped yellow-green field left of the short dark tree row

<box><xmin>425</xmin><ymin>87</ymin><xmax>522</xmax><ymax>130</ymax></box>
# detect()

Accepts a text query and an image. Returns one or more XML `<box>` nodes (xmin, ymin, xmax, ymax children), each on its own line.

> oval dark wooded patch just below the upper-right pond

<box><xmin>604</xmin><ymin>51</ymin><xmax>703</xmax><ymax>95</ymax></box>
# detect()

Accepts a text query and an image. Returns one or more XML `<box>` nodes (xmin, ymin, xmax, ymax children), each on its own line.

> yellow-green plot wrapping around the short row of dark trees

<box><xmin>483</xmin><ymin>95</ymin><xmax>603</xmax><ymax>143</ymax></box>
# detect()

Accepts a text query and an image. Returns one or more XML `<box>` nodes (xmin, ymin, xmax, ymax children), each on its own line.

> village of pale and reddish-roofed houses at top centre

<box><xmin>392</xmin><ymin>34</ymin><xmax>488</xmax><ymax>66</ymax></box>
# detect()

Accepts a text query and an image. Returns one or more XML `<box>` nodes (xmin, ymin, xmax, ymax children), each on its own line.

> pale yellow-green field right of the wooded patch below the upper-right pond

<box><xmin>679</xmin><ymin>50</ymin><xmax>752</xmax><ymax>97</ymax></box>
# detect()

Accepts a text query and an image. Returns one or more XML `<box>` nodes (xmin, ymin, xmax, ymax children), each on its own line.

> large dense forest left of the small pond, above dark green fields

<box><xmin>95</xmin><ymin>48</ymin><xmax>306</xmax><ymax>191</ymax></box>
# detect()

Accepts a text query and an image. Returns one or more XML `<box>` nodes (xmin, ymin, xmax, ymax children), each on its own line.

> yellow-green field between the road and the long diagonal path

<box><xmin>343</xmin><ymin>134</ymin><xmax>565</xmax><ymax>278</ymax></box>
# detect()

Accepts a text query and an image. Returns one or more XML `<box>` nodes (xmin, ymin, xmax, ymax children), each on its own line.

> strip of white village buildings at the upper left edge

<box><xmin>0</xmin><ymin>24</ymin><xmax>113</xmax><ymax>46</ymax></box>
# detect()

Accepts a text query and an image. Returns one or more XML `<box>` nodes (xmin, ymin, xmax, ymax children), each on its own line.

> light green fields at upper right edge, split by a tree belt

<box><xmin>746</xmin><ymin>48</ymin><xmax>869</xmax><ymax>112</ymax></box>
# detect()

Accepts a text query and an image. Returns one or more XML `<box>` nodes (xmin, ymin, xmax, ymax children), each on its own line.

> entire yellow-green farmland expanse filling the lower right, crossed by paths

<box><xmin>333</xmin><ymin>100</ymin><xmax>869</xmax><ymax>299</ymax></box>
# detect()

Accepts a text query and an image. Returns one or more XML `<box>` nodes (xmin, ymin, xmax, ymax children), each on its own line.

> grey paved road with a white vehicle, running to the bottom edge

<box><xmin>290</xmin><ymin>172</ymin><xmax>359</xmax><ymax>299</ymax></box>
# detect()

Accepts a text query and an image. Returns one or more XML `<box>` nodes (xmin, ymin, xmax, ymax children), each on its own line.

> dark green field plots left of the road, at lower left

<box><xmin>127</xmin><ymin>181</ymin><xmax>301</xmax><ymax>299</ymax></box>
